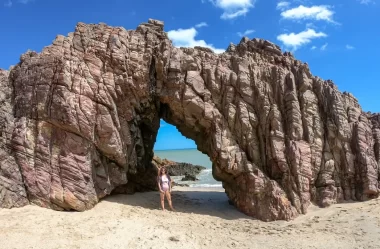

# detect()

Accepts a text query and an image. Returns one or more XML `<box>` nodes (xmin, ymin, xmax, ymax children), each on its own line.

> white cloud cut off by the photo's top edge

<box><xmin>206</xmin><ymin>0</ymin><xmax>256</xmax><ymax>20</ymax></box>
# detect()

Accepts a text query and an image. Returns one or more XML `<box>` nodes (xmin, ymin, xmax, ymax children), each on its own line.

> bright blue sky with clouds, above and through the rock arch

<box><xmin>0</xmin><ymin>0</ymin><xmax>380</xmax><ymax>149</ymax></box>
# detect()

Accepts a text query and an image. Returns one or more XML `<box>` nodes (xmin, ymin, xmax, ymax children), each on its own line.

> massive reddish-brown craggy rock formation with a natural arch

<box><xmin>0</xmin><ymin>20</ymin><xmax>380</xmax><ymax>221</ymax></box>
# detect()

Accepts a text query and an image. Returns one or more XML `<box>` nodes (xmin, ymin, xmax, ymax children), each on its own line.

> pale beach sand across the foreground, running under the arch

<box><xmin>0</xmin><ymin>187</ymin><xmax>380</xmax><ymax>249</ymax></box>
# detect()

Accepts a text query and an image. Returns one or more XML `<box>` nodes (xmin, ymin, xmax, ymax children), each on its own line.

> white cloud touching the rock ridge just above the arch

<box><xmin>168</xmin><ymin>27</ymin><xmax>226</xmax><ymax>54</ymax></box>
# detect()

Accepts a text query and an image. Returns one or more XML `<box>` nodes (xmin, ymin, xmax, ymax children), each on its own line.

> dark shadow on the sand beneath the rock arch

<box><xmin>104</xmin><ymin>189</ymin><xmax>252</xmax><ymax>220</ymax></box>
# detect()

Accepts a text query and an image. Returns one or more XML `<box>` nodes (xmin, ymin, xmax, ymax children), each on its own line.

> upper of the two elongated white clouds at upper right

<box><xmin>281</xmin><ymin>5</ymin><xmax>335</xmax><ymax>23</ymax></box>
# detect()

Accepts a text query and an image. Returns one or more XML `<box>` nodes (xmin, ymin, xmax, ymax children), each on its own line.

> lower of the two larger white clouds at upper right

<box><xmin>277</xmin><ymin>29</ymin><xmax>327</xmax><ymax>50</ymax></box>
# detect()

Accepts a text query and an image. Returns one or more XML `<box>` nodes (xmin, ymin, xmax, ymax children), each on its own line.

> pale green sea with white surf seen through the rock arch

<box><xmin>154</xmin><ymin>149</ymin><xmax>222</xmax><ymax>188</ymax></box>
